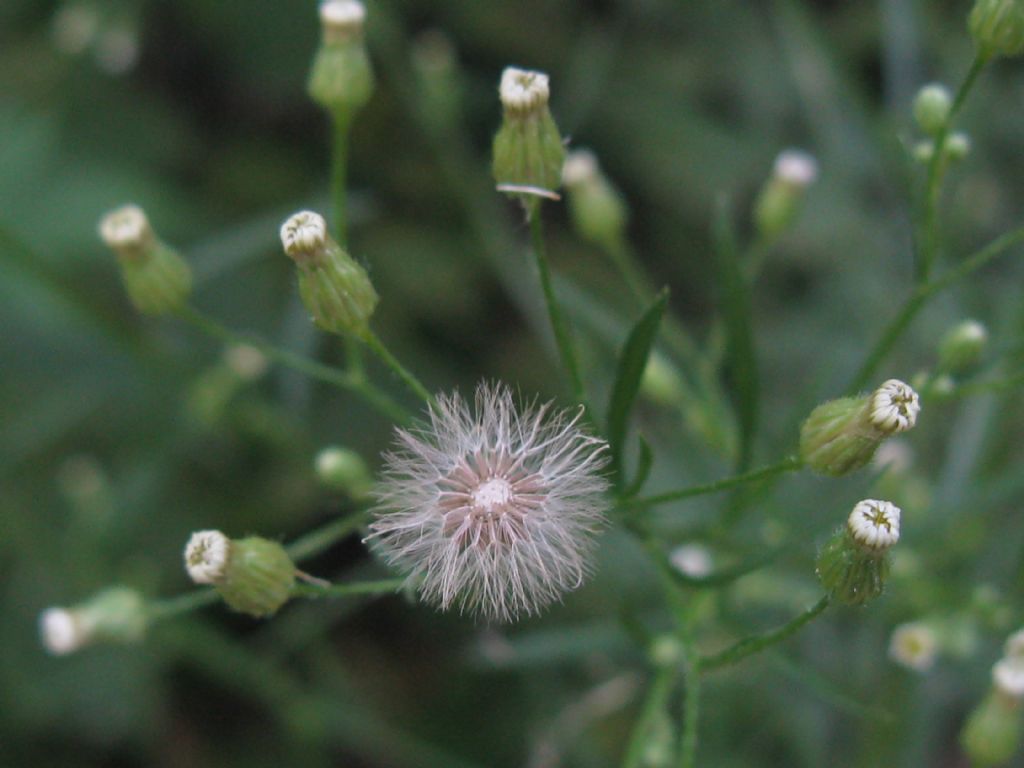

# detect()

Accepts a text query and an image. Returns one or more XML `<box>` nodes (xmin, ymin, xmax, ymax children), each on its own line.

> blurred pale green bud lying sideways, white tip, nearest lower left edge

<box><xmin>39</xmin><ymin>587</ymin><xmax>147</xmax><ymax>655</ymax></box>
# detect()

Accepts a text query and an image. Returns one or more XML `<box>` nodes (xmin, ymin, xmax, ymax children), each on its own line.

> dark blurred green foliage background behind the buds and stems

<box><xmin>6</xmin><ymin>0</ymin><xmax>1024</xmax><ymax>768</ymax></box>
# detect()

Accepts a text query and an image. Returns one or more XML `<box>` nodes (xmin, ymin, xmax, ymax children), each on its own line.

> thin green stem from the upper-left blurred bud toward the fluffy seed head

<box><xmin>177</xmin><ymin>306</ymin><xmax>412</xmax><ymax>424</ymax></box>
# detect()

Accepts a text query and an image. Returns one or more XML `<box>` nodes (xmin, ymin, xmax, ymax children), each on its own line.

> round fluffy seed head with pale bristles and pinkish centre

<box><xmin>370</xmin><ymin>383</ymin><xmax>607</xmax><ymax>621</ymax></box>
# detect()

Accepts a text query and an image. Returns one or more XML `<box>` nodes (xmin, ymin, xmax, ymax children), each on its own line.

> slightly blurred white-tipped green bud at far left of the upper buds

<box><xmin>99</xmin><ymin>205</ymin><xmax>191</xmax><ymax>314</ymax></box>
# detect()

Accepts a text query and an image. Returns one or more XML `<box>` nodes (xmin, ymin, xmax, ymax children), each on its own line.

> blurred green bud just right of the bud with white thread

<box><xmin>562</xmin><ymin>150</ymin><xmax>629</xmax><ymax>251</ymax></box>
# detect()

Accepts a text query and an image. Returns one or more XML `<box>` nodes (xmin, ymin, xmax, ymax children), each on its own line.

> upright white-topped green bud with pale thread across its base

<box><xmin>493</xmin><ymin>67</ymin><xmax>565</xmax><ymax>203</ymax></box>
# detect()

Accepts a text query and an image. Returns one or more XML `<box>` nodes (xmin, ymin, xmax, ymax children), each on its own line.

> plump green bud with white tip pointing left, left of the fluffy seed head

<box><xmin>184</xmin><ymin>530</ymin><xmax>297</xmax><ymax>617</ymax></box>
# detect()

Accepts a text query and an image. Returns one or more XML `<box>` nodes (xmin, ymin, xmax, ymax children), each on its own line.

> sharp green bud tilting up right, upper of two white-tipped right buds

<box><xmin>800</xmin><ymin>379</ymin><xmax>921</xmax><ymax>476</ymax></box>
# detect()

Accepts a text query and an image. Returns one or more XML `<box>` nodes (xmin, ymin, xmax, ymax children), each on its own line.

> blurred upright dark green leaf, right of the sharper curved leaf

<box><xmin>715</xmin><ymin>202</ymin><xmax>759</xmax><ymax>472</ymax></box>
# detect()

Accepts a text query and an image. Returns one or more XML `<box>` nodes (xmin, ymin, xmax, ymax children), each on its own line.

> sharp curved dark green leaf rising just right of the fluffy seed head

<box><xmin>608</xmin><ymin>288</ymin><xmax>669</xmax><ymax>487</ymax></box>
